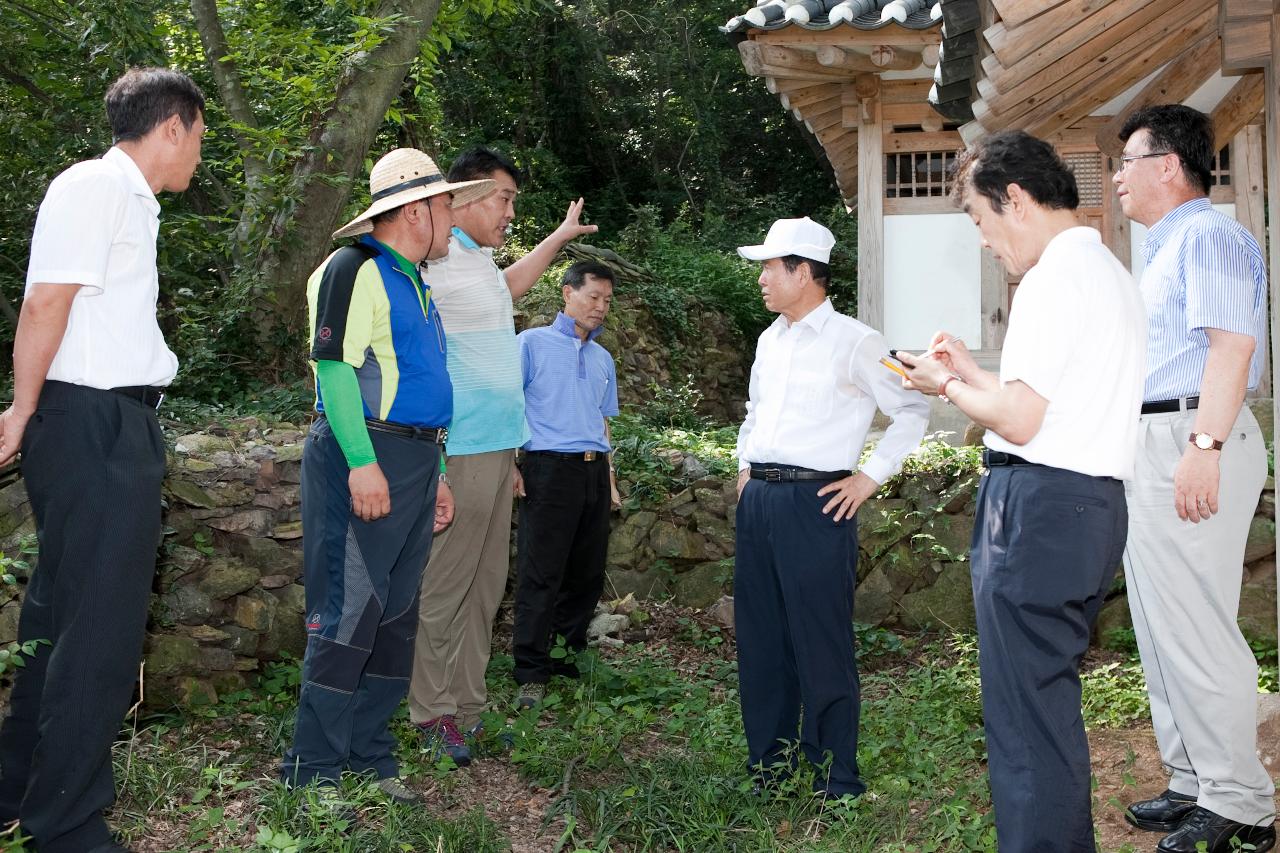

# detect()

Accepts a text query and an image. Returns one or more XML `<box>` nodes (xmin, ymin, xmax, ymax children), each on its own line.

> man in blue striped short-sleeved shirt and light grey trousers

<box><xmin>1114</xmin><ymin>105</ymin><xmax>1275</xmax><ymax>853</ymax></box>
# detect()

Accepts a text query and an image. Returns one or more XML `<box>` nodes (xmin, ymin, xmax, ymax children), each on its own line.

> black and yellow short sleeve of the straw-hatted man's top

<box><xmin>311</xmin><ymin>247</ymin><xmax>381</xmax><ymax>368</ymax></box>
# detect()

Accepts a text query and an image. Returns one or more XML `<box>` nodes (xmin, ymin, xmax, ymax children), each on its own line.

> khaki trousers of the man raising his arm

<box><xmin>408</xmin><ymin>450</ymin><xmax>516</xmax><ymax>729</ymax></box>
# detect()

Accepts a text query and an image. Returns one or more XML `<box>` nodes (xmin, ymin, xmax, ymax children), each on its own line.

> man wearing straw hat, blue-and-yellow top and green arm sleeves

<box><xmin>280</xmin><ymin>149</ymin><xmax>494</xmax><ymax>803</ymax></box>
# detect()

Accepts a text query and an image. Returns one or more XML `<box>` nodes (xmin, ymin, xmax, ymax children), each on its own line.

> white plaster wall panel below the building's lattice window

<box><xmin>882</xmin><ymin>213</ymin><xmax>982</xmax><ymax>350</ymax></box>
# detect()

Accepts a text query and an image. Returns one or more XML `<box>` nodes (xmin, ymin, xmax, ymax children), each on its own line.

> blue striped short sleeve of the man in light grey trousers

<box><xmin>1183</xmin><ymin>228</ymin><xmax>1266</xmax><ymax>337</ymax></box>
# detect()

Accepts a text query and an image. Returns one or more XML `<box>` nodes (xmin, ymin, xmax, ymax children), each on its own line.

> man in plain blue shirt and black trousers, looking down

<box><xmin>512</xmin><ymin>261</ymin><xmax>621</xmax><ymax>708</ymax></box>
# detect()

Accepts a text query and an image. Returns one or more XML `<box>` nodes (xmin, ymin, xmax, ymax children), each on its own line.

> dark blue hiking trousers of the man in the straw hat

<box><xmin>280</xmin><ymin>418</ymin><xmax>440</xmax><ymax>785</ymax></box>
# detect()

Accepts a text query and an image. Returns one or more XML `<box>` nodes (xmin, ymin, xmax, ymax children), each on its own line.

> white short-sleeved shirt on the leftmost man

<box><xmin>27</xmin><ymin>147</ymin><xmax>178</xmax><ymax>388</ymax></box>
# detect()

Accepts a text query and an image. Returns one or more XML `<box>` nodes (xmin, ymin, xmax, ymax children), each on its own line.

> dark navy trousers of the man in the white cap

<box><xmin>733</xmin><ymin>480</ymin><xmax>867</xmax><ymax>797</ymax></box>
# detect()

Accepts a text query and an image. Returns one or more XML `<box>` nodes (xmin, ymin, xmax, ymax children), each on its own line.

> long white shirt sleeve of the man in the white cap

<box><xmin>849</xmin><ymin>333</ymin><xmax>929</xmax><ymax>483</ymax></box>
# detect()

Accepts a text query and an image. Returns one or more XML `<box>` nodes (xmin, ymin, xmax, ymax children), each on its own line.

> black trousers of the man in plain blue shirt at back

<box><xmin>512</xmin><ymin>453</ymin><xmax>609</xmax><ymax>684</ymax></box>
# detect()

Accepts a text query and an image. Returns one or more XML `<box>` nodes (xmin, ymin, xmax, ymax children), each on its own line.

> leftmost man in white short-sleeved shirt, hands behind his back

<box><xmin>0</xmin><ymin>68</ymin><xmax>205</xmax><ymax>853</ymax></box>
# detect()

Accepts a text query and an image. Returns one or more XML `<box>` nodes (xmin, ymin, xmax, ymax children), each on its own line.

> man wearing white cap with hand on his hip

<box><xmin>733</xmin><ymin>216</ymin><xmax>929</xmax><ymax>797</ymax></box>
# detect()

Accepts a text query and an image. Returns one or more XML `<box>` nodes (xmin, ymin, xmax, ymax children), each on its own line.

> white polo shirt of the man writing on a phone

<box><xmin>983</xmin><ymin>227</ymin><xmax>1147</xmax><ymax>479</ymax></box>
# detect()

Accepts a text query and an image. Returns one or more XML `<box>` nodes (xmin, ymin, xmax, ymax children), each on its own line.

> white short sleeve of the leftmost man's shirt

<box><xmin>27</xmin><ymin>170</ymin><xmax>129</xmax><ymax>296</ymax></box>
